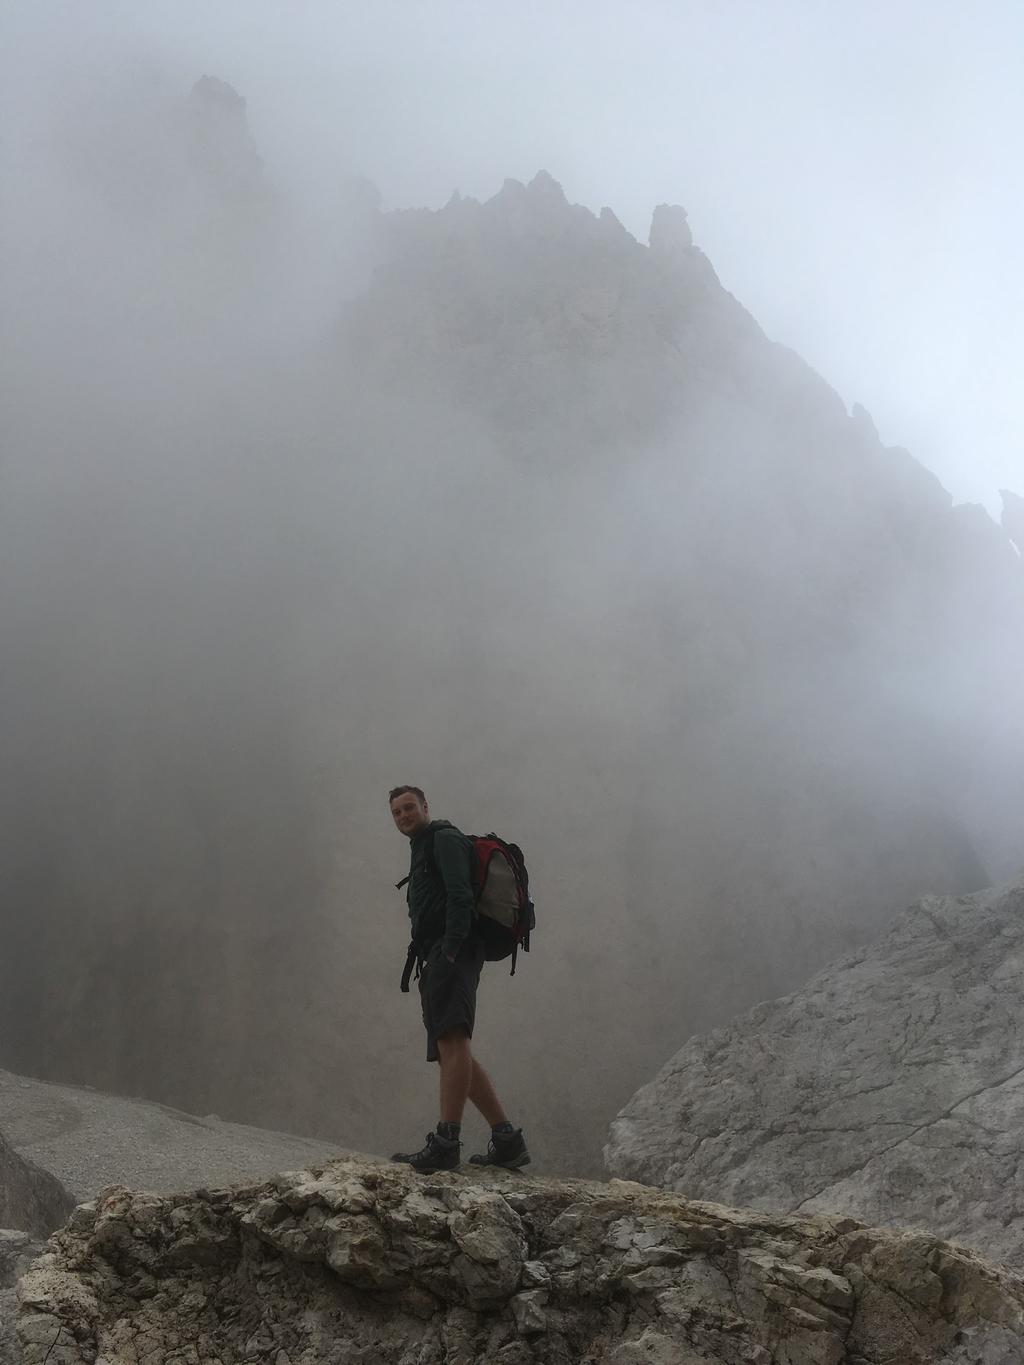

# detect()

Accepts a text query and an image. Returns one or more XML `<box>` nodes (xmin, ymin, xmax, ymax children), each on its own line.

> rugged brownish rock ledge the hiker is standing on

<box><xmin>19</xmin><ymin>1162</ymin><xmax>1024</xmax><ymax>1365</ymax></box>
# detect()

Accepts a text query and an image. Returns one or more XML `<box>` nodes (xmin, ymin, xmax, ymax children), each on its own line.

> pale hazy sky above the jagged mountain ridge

<box><xmin>8</xmin><ymin>0</ymin><xmax>1024</xmax><ymax>511</ymax></box>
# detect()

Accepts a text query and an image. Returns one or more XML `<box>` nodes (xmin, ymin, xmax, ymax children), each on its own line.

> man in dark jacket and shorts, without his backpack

<box><xmin>388</xmin><ymin>786</ymin><xmax>530</xmax><ymax>1174</ymax></box>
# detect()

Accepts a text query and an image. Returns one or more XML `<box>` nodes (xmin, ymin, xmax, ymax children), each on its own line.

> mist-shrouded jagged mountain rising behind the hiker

<box><xmin>0</xmin><ymin>76</ymin><xmax>1024</xmax><ymax>1170</ymax></box>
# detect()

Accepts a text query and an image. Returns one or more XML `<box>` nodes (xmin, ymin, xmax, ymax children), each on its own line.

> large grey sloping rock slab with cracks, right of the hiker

<box><xmin>605</xmin><ymin>882</ymin><xmax>1024</xmax><ymax>1261</ymax></box>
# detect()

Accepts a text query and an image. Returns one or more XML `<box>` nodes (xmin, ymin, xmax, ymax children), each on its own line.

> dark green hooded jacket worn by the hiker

<box><xmin>406</xmin><ymin>820</ymin><xmax>477</xmax><ymax>957</ymax></box>
